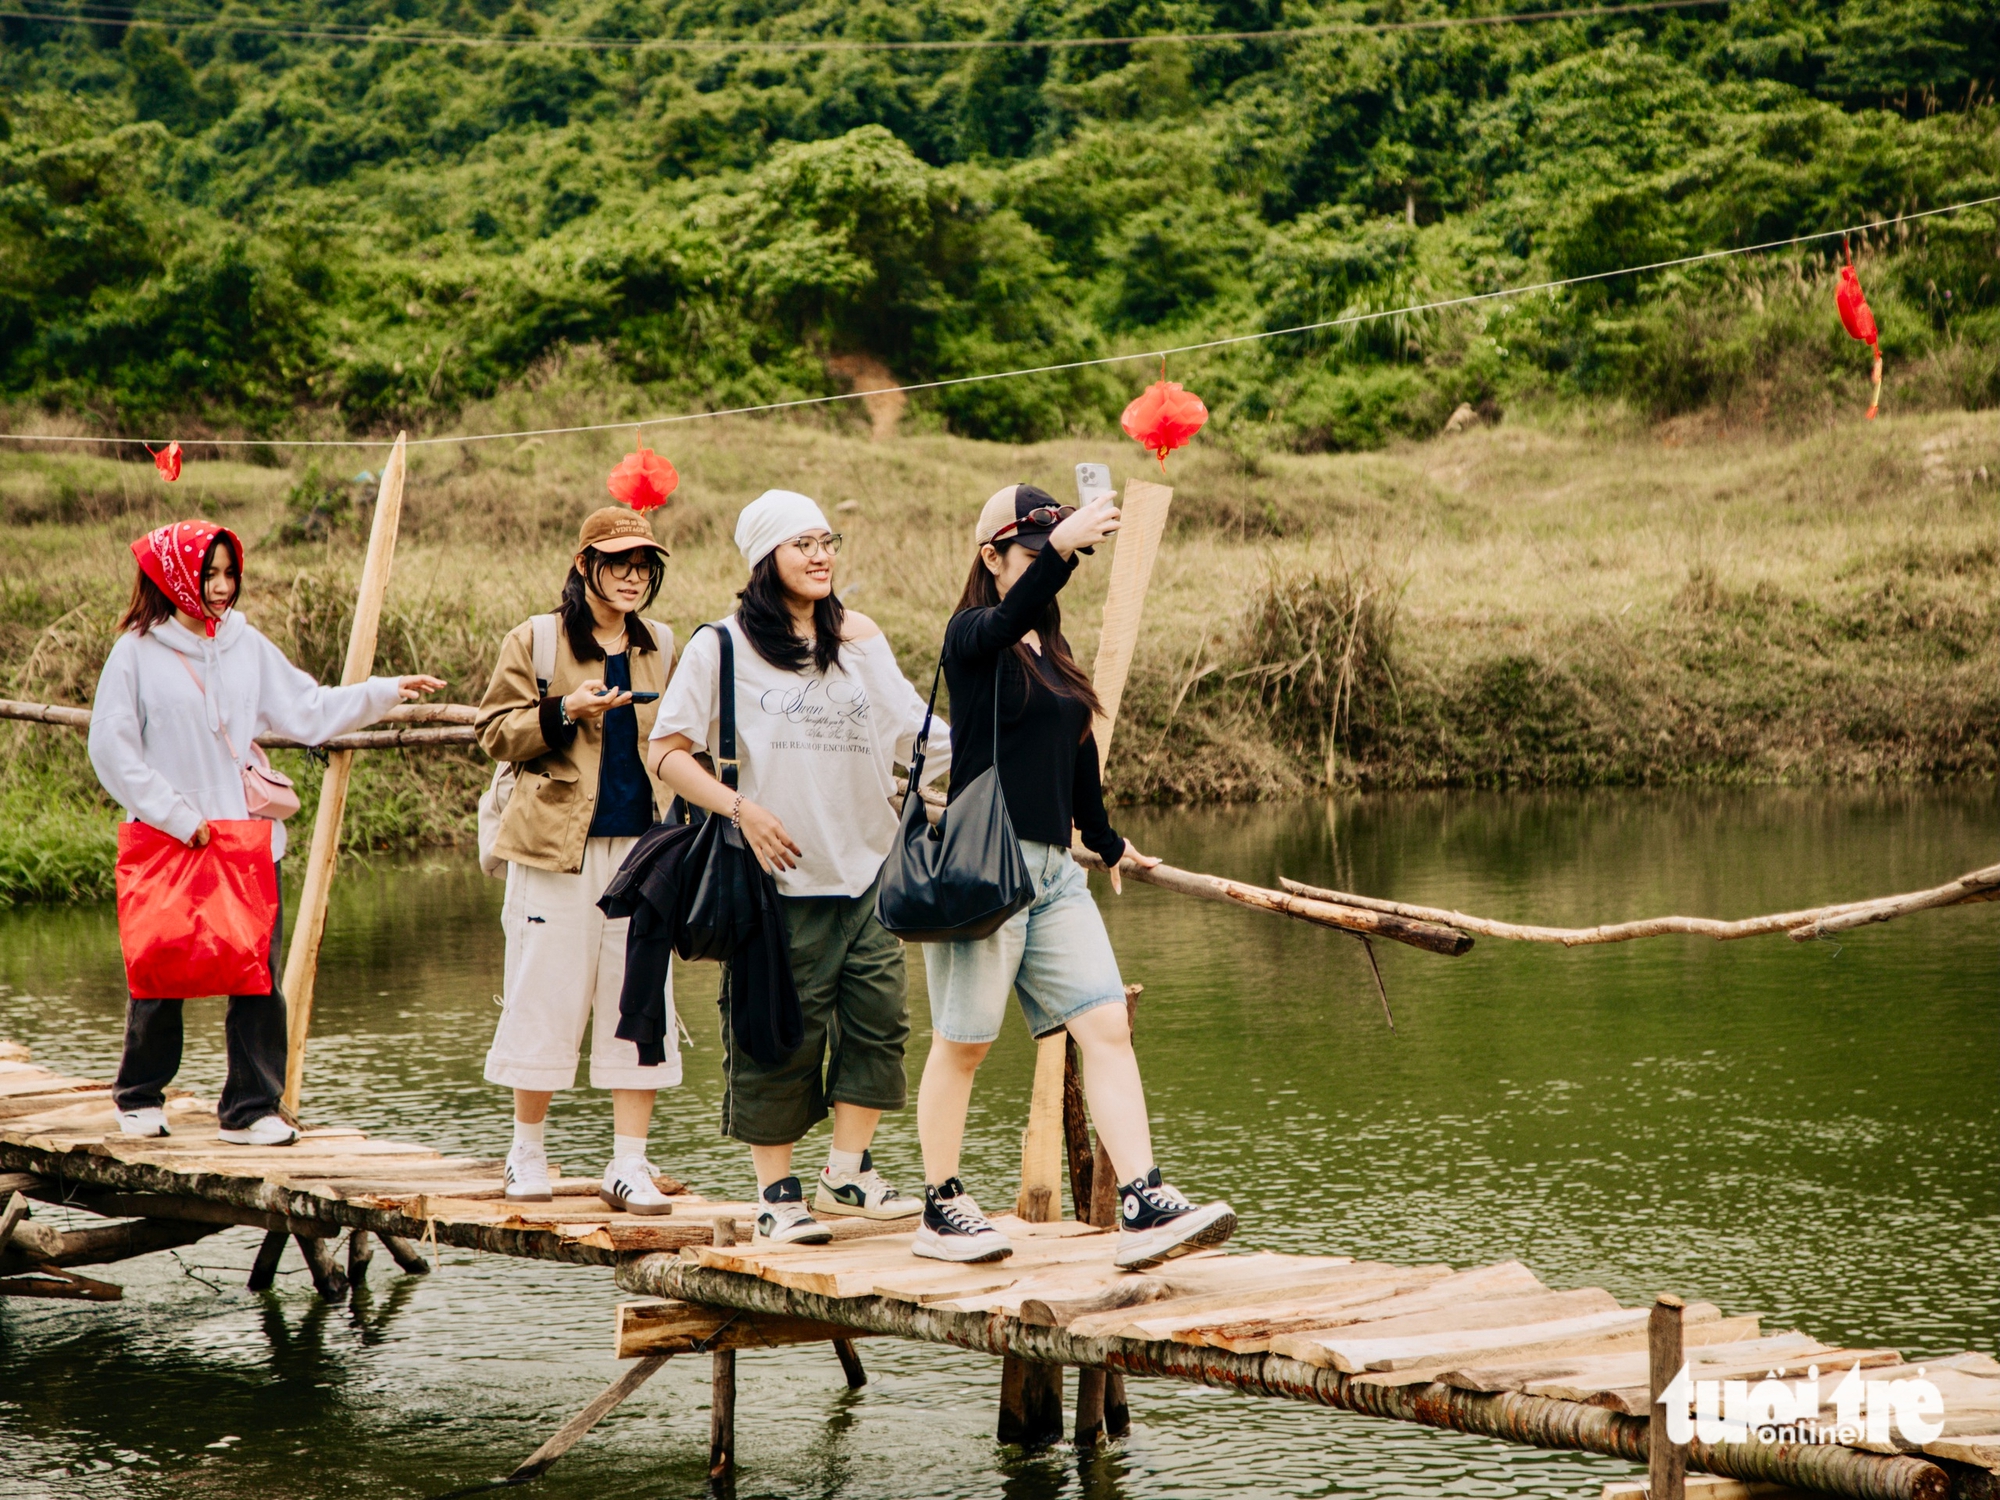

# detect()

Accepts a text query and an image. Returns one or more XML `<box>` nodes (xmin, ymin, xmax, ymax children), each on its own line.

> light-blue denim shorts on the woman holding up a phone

<box><xmin>924</xmin><ymin>838</ymin><xmax>1124</xmax><ymax>1042</ymax></box>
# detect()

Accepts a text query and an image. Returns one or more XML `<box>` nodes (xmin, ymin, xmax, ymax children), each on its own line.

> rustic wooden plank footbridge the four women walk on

<box><xmin>0</xmin><ymin>1042</ymin><xmax>2000</xmax><ymax>1500</ymax></box>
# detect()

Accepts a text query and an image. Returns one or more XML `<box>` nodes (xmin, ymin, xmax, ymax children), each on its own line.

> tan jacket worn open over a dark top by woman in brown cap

<box><xmin>478</xmin><ymin>620</ymin><xmax>674</xmax><ymax>874</ymax></box>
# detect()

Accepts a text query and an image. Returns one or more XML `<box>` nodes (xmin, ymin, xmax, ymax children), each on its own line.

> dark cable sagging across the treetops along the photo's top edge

<box><xmin>0</xmin><ymin>0</ymin><xmax>1730</xmax><ymax>52</ymax></box>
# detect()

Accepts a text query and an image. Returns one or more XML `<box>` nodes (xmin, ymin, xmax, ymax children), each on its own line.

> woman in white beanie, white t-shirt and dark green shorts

<box><xmin>652</xmin><ymin>490</ymin><xmax>950</xmax><ymax>1244</ymax></box>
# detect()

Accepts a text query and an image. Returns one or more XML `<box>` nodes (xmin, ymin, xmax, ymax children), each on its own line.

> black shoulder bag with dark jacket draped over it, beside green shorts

<box><xmin>598</xmin><ymin>624</ymin><xmax>806</xmax><ymax>1068</ymax></box>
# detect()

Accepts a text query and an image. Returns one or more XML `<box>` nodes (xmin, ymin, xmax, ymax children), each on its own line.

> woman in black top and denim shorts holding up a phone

<box><xmin>916</xmin><ymin>484</ymin><xmax>1236</xmax><ymax>1268</ymax></box>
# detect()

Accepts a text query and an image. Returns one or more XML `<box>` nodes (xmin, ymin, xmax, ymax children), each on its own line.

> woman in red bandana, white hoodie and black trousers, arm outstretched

<box><xmin>90</xmin><ymin>520</ymin><xmax>444</xmax><ymax>1146</ymax></box>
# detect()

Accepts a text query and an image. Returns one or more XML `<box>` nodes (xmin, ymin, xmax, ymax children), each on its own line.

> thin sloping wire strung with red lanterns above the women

<box><xmin>0</xmin><ymin>194</ymin><xmax>2000</xmax><ymax>462</ymax></box>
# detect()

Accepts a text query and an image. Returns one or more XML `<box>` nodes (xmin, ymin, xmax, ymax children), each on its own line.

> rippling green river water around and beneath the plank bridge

<box><xmin>0</xmin><ymin>786</ymin><xmax>2000</xmax><ymax>1500</ymax></box>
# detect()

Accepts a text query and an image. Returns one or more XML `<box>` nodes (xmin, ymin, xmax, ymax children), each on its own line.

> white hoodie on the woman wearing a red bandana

<box><xmin>90</xmin><ymin>610</ymin><xmax>402</xmax><ymax>858</ymax></box>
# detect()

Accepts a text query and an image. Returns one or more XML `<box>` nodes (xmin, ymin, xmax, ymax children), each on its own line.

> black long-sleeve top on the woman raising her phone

<box><xmin>944</xmin><ymin>546</ymin><xmax>1124</xmax><ymax>864</ymax></box>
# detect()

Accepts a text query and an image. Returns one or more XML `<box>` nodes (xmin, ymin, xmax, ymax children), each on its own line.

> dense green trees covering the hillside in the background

<box><xmin>0</xmin><ymin>0</ymin><xmax>2000</xmax><ymax>448</ymax></box>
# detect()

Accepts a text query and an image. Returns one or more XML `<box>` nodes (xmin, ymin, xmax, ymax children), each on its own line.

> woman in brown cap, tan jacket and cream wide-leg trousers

<box><xmin>478</xmin><ymin>506</ymin><xmax>680</xmax><ymax>1214</ymax></box>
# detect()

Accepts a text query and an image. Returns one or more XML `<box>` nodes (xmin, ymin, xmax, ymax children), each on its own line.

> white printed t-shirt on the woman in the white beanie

<box><xmin>652</xmin><ymin>616</ymin><xmax>952</xmax><ymax>896</ymax></box>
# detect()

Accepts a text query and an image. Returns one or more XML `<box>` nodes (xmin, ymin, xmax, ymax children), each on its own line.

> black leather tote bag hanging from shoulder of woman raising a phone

<box><xmin>876</xmin><ymin>654</ymin><xmax>1034</xmax><ymax>942</ymax></box>
